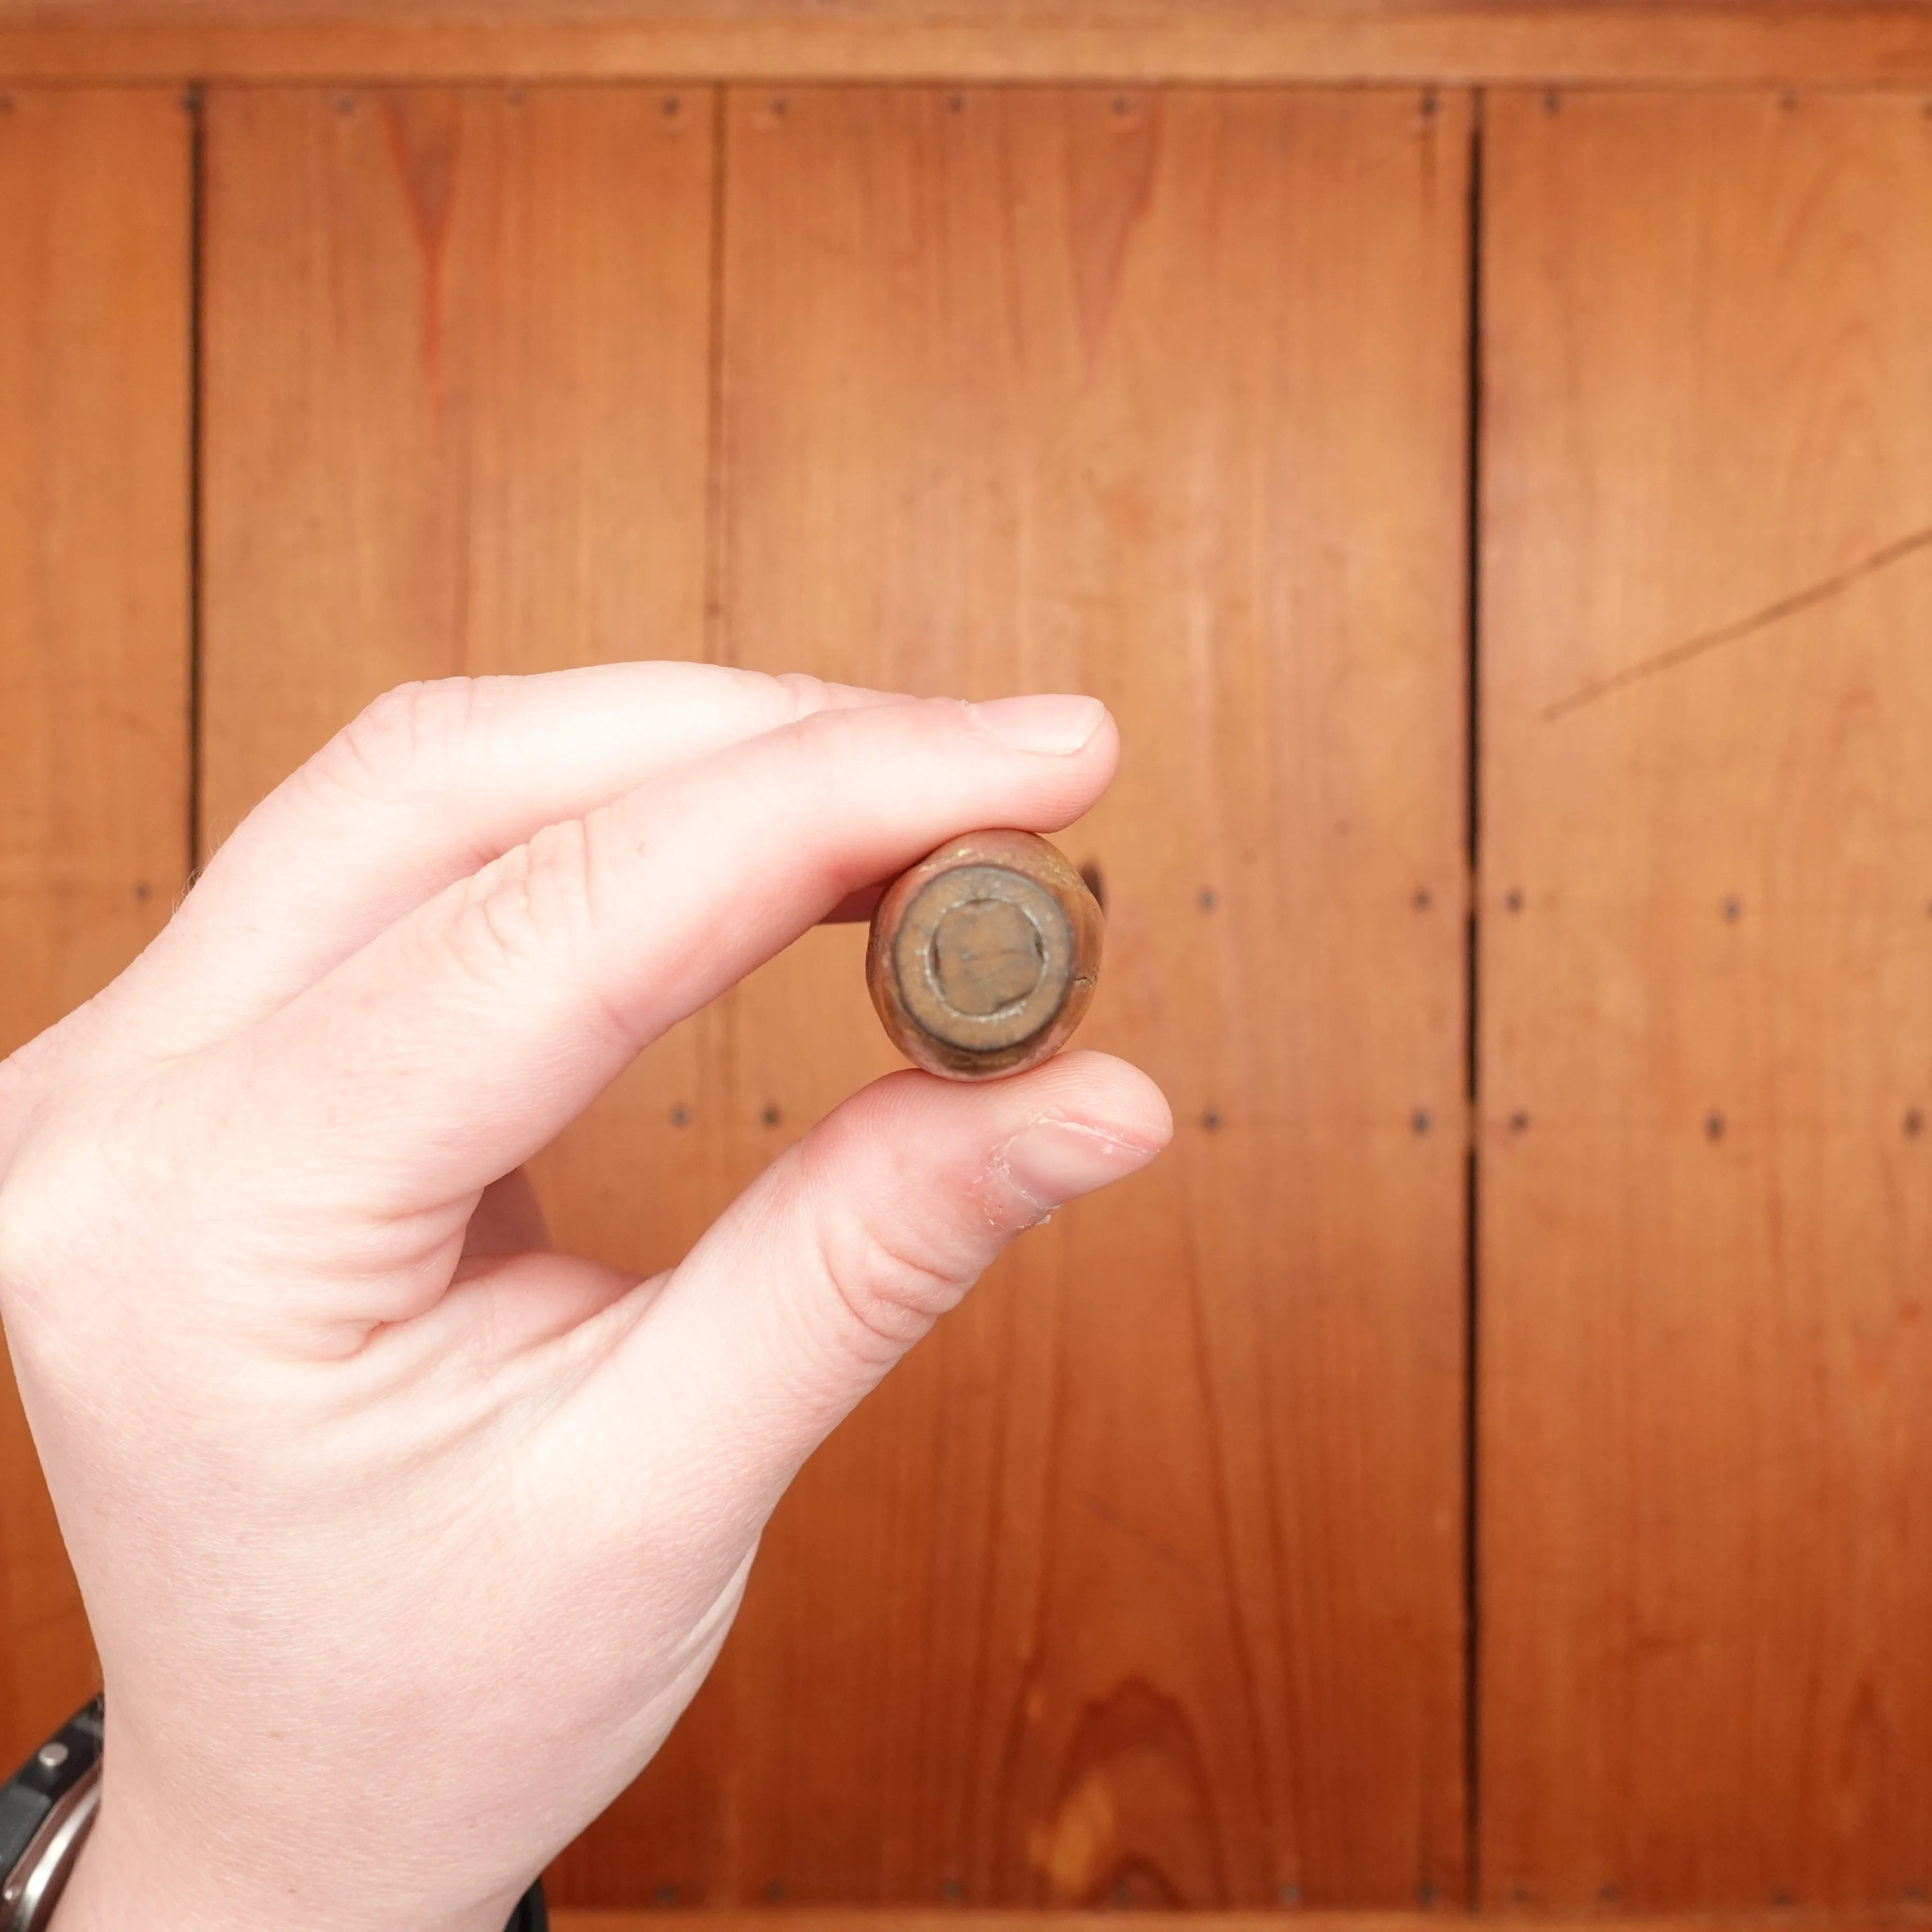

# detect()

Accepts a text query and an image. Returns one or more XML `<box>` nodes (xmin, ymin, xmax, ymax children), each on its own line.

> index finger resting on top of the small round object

<box><xmin>222</xmin><ymin>697</ymin><xmax>1119</xmax><ymax>1320</ymax></box>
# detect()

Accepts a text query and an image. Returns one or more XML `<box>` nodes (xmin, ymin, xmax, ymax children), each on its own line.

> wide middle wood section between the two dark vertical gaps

<box><xmin>205</xmin><ymin>89</ymin><xmax>1468</xmax><ymax>1905</ymax></box>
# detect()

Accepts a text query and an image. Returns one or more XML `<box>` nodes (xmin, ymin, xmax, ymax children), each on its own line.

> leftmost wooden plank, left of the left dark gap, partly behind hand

<box><xmin>0</xmin><ymin>89</ymin><xmax>191</xmax><ymax>1768</ymax></box>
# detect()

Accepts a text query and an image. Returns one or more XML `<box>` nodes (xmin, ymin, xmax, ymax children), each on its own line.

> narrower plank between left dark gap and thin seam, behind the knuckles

<box><xmin>203</xmin><ymin>89</ymin><xmax>721</xmax><ymax>1313</ymax></box>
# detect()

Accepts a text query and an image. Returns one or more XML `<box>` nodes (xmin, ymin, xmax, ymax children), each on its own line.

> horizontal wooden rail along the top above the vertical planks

<box><xmin>0</xmin><ymin>0</ymin><xmax>1932</xmax><ymax>87</ymax></box>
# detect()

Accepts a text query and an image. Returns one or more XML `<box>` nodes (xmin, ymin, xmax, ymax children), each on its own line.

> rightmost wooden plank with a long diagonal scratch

<box><xmin>1480</xmin><ymin>95</ymin><xmax>1932</xmax><ymax>1909</ymax></box>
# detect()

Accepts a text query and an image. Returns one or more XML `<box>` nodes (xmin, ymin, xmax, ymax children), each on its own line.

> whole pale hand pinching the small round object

<box><xmin>0</xmin><ymin>665</ymin><xmax>1171</xmax><ymax>1932</ymax></box>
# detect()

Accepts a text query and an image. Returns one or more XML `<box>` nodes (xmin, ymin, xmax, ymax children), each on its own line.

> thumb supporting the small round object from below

<box><xmin>585</xmin><ymin>1053</ymin><xmax>1173</xmax><ymax>1523</ymax></box>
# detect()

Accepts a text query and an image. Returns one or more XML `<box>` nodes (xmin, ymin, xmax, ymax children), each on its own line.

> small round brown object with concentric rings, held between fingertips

<box><xmin>865</xmin><ymin>831</ymin><xmax>1105</xmax><ymax>1080</ymax></box>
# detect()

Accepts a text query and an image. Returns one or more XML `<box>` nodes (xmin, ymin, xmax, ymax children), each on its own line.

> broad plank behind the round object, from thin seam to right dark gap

<box><xmin>554</xmin><ymin>89</ymin><xmax>1468</xmax><ymax>1907</ymax></box>
